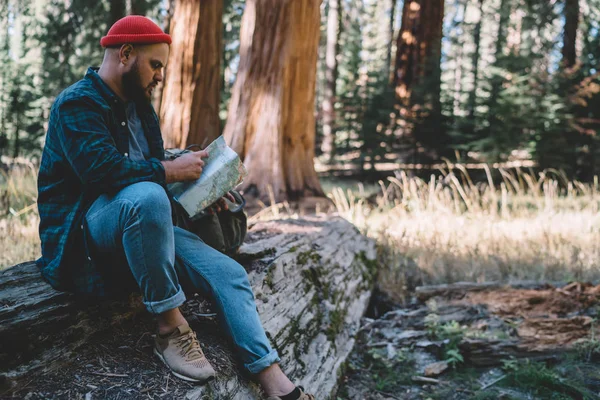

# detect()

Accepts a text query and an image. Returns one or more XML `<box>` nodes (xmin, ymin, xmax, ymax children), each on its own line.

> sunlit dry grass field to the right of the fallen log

<box><xmin>330</xmin><ymin>170</ymin><xmax>600</xmax><ymax>288</ymax></box>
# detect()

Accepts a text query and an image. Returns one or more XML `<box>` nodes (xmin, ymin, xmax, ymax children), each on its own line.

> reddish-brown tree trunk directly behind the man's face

<box><xmin>159</xmin><ymin>0</ymin><xmax>223</xmax><ymax>148</ymax></box>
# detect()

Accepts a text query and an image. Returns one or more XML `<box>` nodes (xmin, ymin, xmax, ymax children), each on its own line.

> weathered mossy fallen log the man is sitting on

<box><xmin>0</xmin><ymin>217</ymin><xmax>375</xmax><ymax>399</ymax></box>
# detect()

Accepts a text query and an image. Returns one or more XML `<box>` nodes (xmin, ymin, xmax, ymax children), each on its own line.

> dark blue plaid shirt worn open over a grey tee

<box><xmin>37</xmin><ymin>68</ymin><xmax>166</xmax><ymax>295</ymax></box>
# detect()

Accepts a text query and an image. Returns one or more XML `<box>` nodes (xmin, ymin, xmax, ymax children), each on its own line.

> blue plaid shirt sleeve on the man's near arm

<box><xmin>57</xmin><ymin>98</ymin><xmax>166</xmax><ymax>193</ymax></box>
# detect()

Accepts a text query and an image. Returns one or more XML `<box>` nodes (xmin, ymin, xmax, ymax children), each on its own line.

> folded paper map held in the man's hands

<box><xmin>168</xmin><ymin>136</ymin><xmax>248</xmax><ymax>218</ymax></box>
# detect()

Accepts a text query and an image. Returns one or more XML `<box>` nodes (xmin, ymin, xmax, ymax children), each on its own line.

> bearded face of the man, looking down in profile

<box><xmin>122</xmin><ymin>43</ymin><xmax>169</xmax><ymax>102</ymax></box>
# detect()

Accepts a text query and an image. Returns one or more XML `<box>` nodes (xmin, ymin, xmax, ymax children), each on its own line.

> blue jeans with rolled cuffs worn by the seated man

<box><xmin>85</xmin><ymin>182</ymin><xmax>280</xmax><ymax>374</ymax></box>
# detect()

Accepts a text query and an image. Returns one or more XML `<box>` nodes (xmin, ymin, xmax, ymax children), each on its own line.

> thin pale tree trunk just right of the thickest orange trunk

<box><xmin>321</xmin><ymin>0</ymin><xmax>342</xmax><ymax>162</ymax></box>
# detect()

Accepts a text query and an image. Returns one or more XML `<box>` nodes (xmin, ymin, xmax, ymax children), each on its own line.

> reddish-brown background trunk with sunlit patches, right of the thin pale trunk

<box><xmin>394</xmin><ymin>0</ymin><xmax>444</xmax><ymax>106</ymax></box>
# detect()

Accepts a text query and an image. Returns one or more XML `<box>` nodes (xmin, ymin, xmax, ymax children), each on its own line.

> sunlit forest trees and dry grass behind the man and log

<box><xmin>0</xmin><ymin>0</ymin><xmax>600</xmax><ymax>290</ymax></box>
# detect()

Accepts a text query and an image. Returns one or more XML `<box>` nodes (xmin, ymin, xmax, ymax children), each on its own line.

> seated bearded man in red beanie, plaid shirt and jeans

<box><xmin>38</xmin><ymin>16</ymin><xmax>314</xmax><ymax>400</ymax></box>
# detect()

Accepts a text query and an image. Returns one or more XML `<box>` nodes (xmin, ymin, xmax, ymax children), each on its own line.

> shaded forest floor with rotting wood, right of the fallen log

<box><xmin>337</xmin><ymin>283</ymin><xmax>600</xmax><ymax>400</ymax></box>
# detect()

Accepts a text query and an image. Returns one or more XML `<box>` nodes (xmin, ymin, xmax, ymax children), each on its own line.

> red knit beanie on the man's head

<box><xmin>100</xmin><ymin>15</ymin><xmax>171</xmax><ymax>47</ymax></box>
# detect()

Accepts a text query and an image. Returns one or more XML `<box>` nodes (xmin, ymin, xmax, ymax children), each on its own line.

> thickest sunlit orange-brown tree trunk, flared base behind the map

<box><xmin>224</xmin><ymin>0</ymin><xmax>323</xmax><ymax>201</ymax></box>
